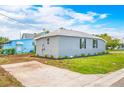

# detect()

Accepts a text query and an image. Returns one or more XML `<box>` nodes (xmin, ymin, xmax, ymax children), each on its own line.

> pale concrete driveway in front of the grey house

<box><xmin>2</xmin><ymin>61</ymin><xmax>103</xmax><ymax>87</ymax></box>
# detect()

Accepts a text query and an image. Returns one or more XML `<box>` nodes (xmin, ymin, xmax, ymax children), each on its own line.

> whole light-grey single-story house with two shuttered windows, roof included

<box><xmin>35</xmin><ymin>29</ymin><xmax>106</xmax><ymax>58</ymax></box>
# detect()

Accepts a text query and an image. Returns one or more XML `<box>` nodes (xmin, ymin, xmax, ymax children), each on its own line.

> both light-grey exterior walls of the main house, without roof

<box><xmin>36</xmin><ymin>36</ymin><xmax>105</xmax><ymax>58</ymax></box>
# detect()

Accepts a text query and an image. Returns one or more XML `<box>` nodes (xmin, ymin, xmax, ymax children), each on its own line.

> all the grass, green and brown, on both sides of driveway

<box><xmin>0</xmin><ymin>53</ymin><xmax>124</xmax><ymax>86</ymax></box>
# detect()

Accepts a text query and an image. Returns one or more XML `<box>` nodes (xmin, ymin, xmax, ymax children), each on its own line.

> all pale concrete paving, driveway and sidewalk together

<box><xmin>1</xmin><ymin>61</ymin><xmax>124</xmax><ymax>87</ymax></box>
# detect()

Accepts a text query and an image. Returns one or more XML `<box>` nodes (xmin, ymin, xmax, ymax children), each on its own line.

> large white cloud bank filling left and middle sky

<box><xmin>0</xmin><ymin>6</ymin><xmax>110</xmax><ymax>39</ymax></box>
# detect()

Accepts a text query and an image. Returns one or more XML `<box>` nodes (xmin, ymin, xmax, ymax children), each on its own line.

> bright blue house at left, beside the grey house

<box><xmin>2</xmin><ymin>39</ymin><xmax>34</xmax><ymax>53</ymax></box>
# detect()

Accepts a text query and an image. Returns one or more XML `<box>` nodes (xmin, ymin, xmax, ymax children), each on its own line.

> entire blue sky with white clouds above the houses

<box><xmin>0</xmin><ymin>5</ymin><xmax>124</xmax><ymax>40</ymax></box>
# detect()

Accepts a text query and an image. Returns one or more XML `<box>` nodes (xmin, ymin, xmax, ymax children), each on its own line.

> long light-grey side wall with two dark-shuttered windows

<box><xmin>59</xmin><ymin>36</ymin><xmax>106</xmax><ymax>57</ymax></box>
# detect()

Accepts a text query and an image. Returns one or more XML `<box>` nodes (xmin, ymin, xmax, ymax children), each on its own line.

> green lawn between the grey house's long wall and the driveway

<box><xmin>46</xmin><ymin>53</ymin><xmax>124</xmax><ymax>74</ymax></box>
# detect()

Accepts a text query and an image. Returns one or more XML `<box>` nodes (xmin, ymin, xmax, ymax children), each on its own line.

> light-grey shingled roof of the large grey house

<box><xmin>35</xmin><ymin>29</ymin><xmax>103</xmax><ymax>40</ymax></box>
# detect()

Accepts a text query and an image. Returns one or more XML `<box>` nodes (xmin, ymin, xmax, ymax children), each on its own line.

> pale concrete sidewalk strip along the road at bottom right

<box><xmin>86</xmin><ymin>69</ymin><xmax>124</xmax><ymax>87</ymax></box>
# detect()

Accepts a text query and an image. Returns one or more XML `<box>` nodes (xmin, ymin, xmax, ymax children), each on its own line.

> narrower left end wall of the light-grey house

<box><xmin>36</xmin><ymin>37</ymin><xmax>58</xmax><ymax>58</ymax></box>
